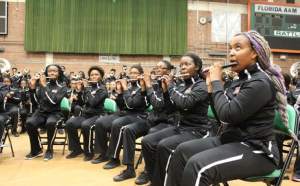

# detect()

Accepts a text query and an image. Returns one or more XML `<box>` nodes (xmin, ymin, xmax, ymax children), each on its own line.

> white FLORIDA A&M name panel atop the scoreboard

<box><xmin>255</xmin><ymin>4</ymin><xmax>300</xmax><ymax>15</ymax></box>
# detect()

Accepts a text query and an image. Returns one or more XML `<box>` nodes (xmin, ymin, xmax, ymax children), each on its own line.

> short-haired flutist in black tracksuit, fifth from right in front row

<box><xmin>66</xmin><ymin>66</ymin><xmax>108</xmax><ymax>161</ymax></box>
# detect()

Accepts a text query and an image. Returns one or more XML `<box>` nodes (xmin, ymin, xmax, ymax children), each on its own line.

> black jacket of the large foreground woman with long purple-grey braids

<box><xmin>212</xmin><ymin>64</ymin><xmax>278</xmax><ymax>164</ymax></box>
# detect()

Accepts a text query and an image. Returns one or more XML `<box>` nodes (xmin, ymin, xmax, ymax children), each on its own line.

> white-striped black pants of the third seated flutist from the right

<box><xmin>107</xmin><ymin>115</ymin><xmax>149</xmax><ymax>164</ymax></box>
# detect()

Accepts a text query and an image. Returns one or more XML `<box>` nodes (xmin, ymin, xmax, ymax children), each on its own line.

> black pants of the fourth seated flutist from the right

<box><xmin>95</xmin><ymin>114</ymin><xmax>120</xmax><ymax>156</ymax></box>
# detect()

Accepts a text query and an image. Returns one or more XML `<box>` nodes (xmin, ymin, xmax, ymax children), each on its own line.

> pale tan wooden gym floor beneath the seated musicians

<box><xmin>0</xmin><ymin>134</ymin><xmax>300</xmax><ymax>186</ymax></box>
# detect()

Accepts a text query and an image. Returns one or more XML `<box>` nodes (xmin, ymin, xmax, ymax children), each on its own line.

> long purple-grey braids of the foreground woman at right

<box><xmin>242</xmin><ymin>31</ymin><xmax>288</xmax><ymax>126</ymax></box>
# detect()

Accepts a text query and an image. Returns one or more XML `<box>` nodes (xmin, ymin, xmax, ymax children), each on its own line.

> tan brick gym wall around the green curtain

<box><xmin>0</xmin><ymin>0</ymin><xmax>300</xmax><ymax>75</ymax></box>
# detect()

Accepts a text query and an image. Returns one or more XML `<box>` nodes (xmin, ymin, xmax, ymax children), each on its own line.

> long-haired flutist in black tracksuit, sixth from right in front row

<box><xmin>25</xmin><ymin>64</ymin><xmax>67</xmax><ymax>161</ymax></box>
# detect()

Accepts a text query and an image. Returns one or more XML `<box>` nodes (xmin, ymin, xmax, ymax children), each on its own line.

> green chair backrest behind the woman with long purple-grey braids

<box><xmin>274</xmin><ymin>105</ymin><xmax>298</xmax><ymax>135</ymax></box>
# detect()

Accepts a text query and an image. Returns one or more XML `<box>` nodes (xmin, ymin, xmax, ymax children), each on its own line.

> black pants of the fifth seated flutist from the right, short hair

<box><xmin>66</xmin><ymin>116</ymin><xmax>98</xmax><ymax>155</ymax></box>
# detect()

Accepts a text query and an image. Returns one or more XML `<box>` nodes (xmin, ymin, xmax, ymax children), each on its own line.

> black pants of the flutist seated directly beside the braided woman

<box><xmin>142</xmin><ymin>126</ymin><xmax>208</xmax><ymax>186</ymax></box>
